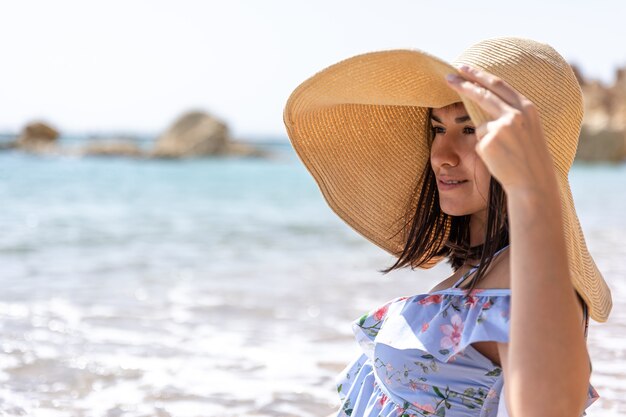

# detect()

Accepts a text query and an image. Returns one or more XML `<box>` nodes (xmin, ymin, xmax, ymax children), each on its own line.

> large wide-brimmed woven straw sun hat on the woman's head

<box><xmin>284</xmin><ymin>38</ymin><xmax>612</xmax><ymax>322</ymax></box>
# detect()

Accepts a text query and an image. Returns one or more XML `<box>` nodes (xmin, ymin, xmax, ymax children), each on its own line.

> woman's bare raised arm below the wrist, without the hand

<box><xmin>506</xmin><ymin>187</ymin><xmax>590</xmax><ymax>417</ymax></box>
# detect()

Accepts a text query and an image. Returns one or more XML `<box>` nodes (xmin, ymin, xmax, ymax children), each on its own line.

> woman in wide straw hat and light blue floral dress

<box><xmin>285</xmin><ymin>38</ymin><xmax>611</xmax><ymax>417</ymax></box>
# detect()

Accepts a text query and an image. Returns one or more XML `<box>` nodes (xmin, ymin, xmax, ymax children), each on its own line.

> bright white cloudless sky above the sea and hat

<box><xmin>0</xmin><ymin>0</ymin><xmax>626</xmax><ymax>140</ymax></box>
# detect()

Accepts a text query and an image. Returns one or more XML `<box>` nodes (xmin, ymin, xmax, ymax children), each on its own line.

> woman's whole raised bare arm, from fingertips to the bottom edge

<box><xmin>450</xmin><ymin>66</ymin><xmax>590</xmax><ymax>417</ymax></box>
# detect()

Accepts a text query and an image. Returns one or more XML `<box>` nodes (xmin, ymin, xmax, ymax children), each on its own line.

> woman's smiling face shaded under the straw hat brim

<box><xmin>430</xmin><ymin>103</ymin><xmax>491</xmax><ymax>223</ymax></box>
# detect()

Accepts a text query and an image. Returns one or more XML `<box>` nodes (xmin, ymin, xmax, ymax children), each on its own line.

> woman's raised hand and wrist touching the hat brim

<box><xmin>448</xmin><ymin>66</ymin><xmax>557</xmax><ymax>194</ymax></box>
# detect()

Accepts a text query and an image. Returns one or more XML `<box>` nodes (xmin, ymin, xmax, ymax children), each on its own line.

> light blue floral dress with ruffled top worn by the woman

<box><xmin>337</xmin><ymin>248</ymin><xmax>599</xmax><ymax>417</ymax></box>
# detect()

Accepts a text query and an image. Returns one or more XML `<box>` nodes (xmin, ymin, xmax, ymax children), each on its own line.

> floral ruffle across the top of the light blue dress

<box><xmin>352</xmin><ymin>288</ymin><xmax>511</xmax><ymax>362</ymax></box>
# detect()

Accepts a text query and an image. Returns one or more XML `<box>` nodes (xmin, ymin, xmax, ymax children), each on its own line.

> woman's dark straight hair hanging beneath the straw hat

<box><xmin>379</xmin><ymin>105</ymin><xmax>509</xmax><ymax>290</ymax></box>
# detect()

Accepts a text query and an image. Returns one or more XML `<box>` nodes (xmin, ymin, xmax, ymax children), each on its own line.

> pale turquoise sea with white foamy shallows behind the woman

<box><xmin>0</xmin><ymin>140</ymin><xmax>626</xmax><ymax>417</ymax></box>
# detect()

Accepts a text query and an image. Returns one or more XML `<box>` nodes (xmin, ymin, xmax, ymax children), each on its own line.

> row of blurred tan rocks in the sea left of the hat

<box><xmin>0</xmin><ymin>111</ymin><xmax>270</xmax><ymax>159</ymax></box>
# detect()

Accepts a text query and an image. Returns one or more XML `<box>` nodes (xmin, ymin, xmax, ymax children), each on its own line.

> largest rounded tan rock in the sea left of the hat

<box><xmin>152</xmin><ymin>111</ymin><xmax>230</xmax><ymax>158</ymax></box>
